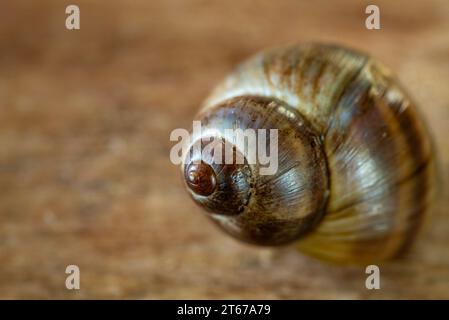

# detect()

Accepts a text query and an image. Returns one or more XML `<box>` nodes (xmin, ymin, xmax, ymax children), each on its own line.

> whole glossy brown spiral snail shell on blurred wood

<box><xmin>182</xmin><ymin>44</ymin><xmax>434</xmax><ymax>263</ymax></box>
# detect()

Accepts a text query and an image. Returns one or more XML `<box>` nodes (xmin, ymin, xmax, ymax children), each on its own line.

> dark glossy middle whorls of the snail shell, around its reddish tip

<box><xmin>187</xmin><ymin>96</ymin><xmax>329</xmax><ymax>245</ymax></box>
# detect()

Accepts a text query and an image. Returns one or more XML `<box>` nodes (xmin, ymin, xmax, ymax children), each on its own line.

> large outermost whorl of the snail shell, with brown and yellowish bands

<box><xmin>198</xmin><ymin>44</ymin><xmax>435</xmax><ymax>263</ymax></box>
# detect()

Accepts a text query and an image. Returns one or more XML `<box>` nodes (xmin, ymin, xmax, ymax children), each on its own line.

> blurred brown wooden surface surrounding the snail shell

<box><xmin>0</xmin><ymin>0</ymin><xmax>449</xmax><ymax>299</ymax></box>
